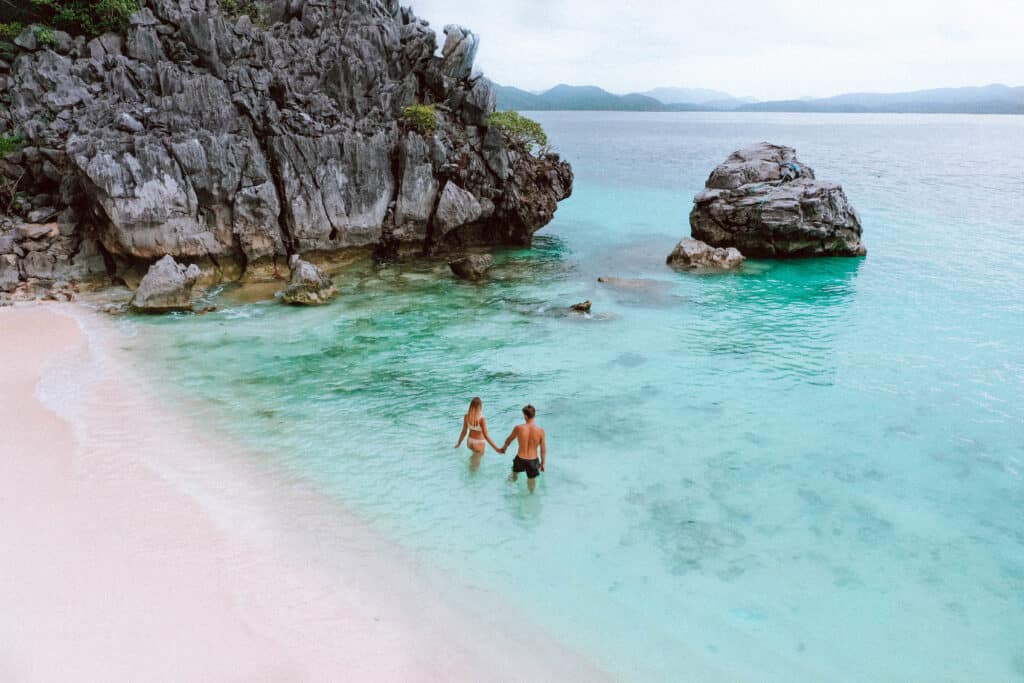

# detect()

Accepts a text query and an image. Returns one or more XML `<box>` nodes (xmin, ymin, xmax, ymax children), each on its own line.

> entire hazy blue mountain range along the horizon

<box><xmin>497</xmin><ymin>84</ymin><xmax>1024</xmax><ymax>115</ymax></box>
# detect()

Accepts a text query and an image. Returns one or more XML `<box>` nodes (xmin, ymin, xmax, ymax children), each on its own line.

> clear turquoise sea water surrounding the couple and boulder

<box><xmin>125</xmin><ymin>113</ymin><xmax>1024</xmax><ymax>681</ymax></box>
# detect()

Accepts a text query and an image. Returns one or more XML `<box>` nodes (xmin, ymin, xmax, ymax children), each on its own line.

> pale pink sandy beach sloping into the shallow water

<box><xmin>0</xmin><ymin>304</ymin><xmax>606</xmax><ymax>681</ymax></box>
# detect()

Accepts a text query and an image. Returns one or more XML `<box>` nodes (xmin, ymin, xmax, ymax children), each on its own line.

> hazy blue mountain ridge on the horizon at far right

<box><xmin>739</xmin><ymin>85</ymin><xmax>1024</xmax><ymax>114</ymax></box>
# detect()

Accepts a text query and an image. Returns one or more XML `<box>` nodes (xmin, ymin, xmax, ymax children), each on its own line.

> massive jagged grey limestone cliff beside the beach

<box><xmin>0</xmin><ymin>0</ymin><xmax>572</xmax><ymax>286</ymax></box>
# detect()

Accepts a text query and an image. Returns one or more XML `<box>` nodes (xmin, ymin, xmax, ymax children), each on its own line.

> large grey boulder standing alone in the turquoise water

<box><xmin>690</xmin><ymin>142</ymin><xmax>867</xmax><ymax>258</ymax></box>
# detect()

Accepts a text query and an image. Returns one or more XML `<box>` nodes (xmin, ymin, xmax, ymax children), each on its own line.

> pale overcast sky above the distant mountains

<box><xmin>402</xmin><ymin>0</ymin><xmax>1024</xmax><ymax>99</ymax></box>
